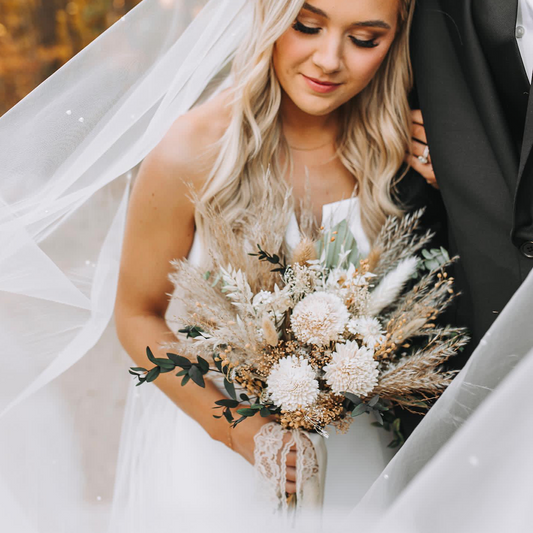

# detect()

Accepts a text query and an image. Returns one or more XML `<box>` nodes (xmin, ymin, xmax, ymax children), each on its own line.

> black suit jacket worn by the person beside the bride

<box><xmin>412</xmin><ymin>0</ymin><xmax>533</xmax><ymax>358</ymax></box>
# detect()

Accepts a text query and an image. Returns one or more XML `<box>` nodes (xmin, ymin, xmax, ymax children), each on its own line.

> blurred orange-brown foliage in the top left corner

<box><xmin>0</xmin><ymin>0</ymin><xmax>141</xmax><ymax>116</ymax></box>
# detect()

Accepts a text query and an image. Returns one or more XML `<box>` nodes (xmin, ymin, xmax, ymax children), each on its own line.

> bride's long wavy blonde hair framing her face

<box><xmin>195</xmin><ymin>0</ymin><xmax>414</xmax><ymax>245</ymax></box>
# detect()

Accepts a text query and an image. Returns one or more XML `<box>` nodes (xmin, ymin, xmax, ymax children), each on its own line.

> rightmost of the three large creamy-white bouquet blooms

<box><xmin>324</xmin><ymin>341</ymin><xmax>379</xmax><ymax>396</ymax></box>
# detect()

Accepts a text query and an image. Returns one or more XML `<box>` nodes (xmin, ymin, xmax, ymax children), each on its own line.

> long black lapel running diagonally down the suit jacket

<box><xmin>440</xmin><ymin>0</ymin><xmax>519</xmax><ymax>191</ymax></box>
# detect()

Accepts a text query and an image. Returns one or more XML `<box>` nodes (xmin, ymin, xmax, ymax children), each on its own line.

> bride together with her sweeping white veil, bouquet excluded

<box><xmin>0</xmin><ymin>0</ymin><xmax>533</xmax><ymax>533</ymax></box>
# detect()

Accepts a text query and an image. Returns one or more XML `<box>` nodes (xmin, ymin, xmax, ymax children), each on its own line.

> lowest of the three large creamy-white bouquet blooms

<box><xmin>267</xmin><ymin>355</ymin><xmax>318</xmax><ymax>411</ymax></box>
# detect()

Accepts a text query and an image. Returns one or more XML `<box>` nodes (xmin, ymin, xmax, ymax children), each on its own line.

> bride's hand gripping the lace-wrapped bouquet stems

<box><xmin>227</xmin><ymin>416</ymin><xmax>296</xmax><ymax>494</ymax></box>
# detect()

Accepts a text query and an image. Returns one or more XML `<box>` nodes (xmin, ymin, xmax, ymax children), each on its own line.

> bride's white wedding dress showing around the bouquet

<box><xmin>109</xmin><ymin>198</ymin><xmax>394</xmax><ymax>533</ymax></box>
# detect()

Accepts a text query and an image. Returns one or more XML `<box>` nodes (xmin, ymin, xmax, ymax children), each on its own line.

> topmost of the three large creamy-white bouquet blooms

<box><xmin>291</xmin><ymin>291</ymin><xmax>350</xmax><ymax>346</ymax></box>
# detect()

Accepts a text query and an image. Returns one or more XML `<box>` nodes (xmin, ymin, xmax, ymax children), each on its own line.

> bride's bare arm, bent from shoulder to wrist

<box><xmin>115</xmin><ymin>116</ymin><xmax>278</xmax><ymax>470</ymax></box>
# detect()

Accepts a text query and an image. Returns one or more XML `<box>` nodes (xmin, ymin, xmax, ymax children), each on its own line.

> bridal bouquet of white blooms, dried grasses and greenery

<box><xmin>130</xmin><ymin>207</ymin><xmax>467</xmax><ymax>446</ymax></box>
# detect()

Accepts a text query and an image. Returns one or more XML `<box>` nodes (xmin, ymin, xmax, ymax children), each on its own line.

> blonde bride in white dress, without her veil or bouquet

<box><xmin>111</xmin><ymin>0</ymin><xmax>420</xmax><ymax>532</ymax></box>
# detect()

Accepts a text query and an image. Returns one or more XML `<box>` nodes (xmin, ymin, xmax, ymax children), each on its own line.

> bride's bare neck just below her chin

<box><xmin>280</xmin><ymin>89</ymin><xmax>338</xmax><ymax>148</ymax></box>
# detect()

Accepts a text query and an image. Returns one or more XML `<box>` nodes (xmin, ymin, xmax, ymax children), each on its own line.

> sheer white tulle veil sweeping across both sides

<box><xmin>0</xmin><ymin>0</ymin><xmax>533</xmax><ymax>533</ymax></box>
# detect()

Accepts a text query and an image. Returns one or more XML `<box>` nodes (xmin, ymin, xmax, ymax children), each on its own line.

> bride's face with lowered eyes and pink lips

<box><xmin>273</xmin><ymin>0</ymin><xmax>399</xmax><ymax>116</ymax></box>
